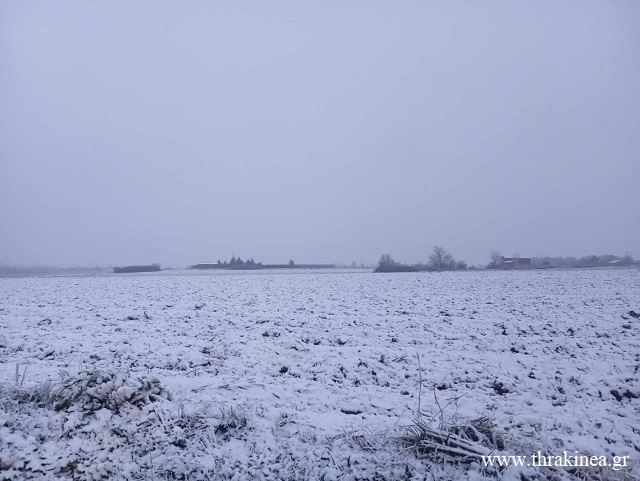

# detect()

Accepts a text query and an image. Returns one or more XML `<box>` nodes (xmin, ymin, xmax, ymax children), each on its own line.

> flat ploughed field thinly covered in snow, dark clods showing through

<box><xmin>0</xmin><ymin>270</ymin><xmax>640</xmax><ymax>480</ymax></box>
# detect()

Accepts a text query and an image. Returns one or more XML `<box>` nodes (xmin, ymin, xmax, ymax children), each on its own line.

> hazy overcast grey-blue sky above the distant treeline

<box><xmin>0</xmin><ymin>1</ymin><xmax>640</xmax><ymax>266</ymax></box>
